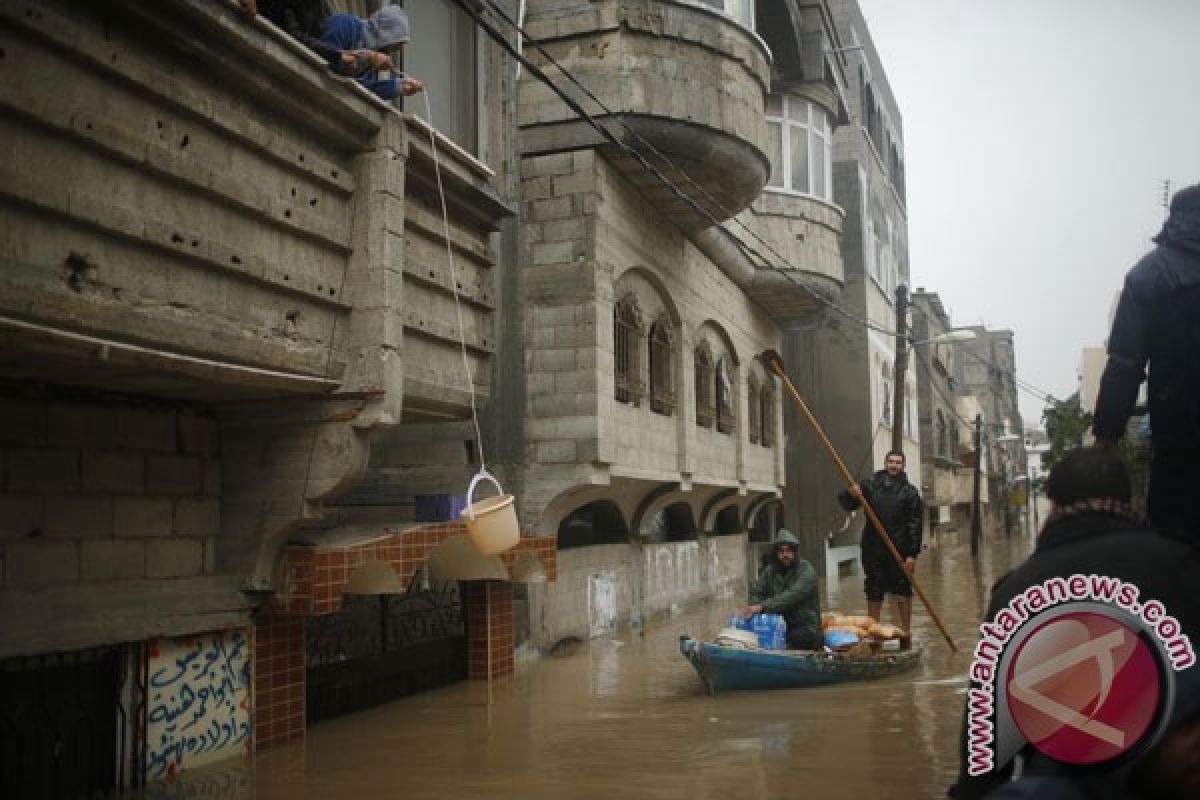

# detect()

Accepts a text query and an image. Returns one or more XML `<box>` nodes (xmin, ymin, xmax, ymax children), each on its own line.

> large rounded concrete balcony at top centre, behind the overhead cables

<box><xmin>518</xmin><ymin>0</ymin><xmax>770</xmax><ymax>230</ymax></box>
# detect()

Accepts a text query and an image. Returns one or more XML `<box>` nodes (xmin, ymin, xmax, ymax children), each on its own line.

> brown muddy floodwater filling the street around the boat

<box><xmin>140</xmin><ymin>536</ymin><xmax>1031</xmax><ymax>800</ymax></box>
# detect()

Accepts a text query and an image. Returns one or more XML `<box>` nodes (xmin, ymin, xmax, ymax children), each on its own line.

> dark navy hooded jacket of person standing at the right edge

<box><xmin>1093</xmin><ymin>186</ymin><xmax>1200</xmax><ymax>449</ymax></box>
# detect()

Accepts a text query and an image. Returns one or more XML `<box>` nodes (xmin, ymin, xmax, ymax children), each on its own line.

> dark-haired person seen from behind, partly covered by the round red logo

<box><xmin>948</xmin><ymin>447</ymin><xmax>1200</xmax><ymax>800</ymax></box>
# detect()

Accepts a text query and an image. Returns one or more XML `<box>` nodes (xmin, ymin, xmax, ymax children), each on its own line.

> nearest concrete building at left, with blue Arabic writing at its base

<box><xmin>0</xmin><ymin>0</ymin><xmax>520</xmax><ymax>796</ymax></box>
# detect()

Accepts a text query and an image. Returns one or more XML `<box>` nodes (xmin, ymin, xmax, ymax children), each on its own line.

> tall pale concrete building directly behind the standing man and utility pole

<box><xmin>785</xmin><ymin>0</ymin><xmax>922</xmax><ymax>564</ymax></box>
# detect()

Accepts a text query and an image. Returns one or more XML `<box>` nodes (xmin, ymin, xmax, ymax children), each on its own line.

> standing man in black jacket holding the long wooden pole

<box><xmin>838</xmin><ymin>450</ymin><xmax>924</xmax><ymax>632</ymax></box>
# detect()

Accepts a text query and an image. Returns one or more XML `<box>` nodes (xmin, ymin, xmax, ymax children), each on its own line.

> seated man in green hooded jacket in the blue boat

<box><xmin>742</xmin><ymin>528</ymin><xmax>821</xmax><ymax>650</ymax></box>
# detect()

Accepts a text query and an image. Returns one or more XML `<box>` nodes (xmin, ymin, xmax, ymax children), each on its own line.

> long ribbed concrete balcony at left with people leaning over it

<box><xmin>0</xmin><ymin>0</ymin><xmax>508</xmax><ymax>419</ymax></box>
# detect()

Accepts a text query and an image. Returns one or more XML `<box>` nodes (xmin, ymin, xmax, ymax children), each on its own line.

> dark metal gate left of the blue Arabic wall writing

<box><xmin>0</xmin><ymin>646</ymin><xmax>133</xmax><ymax>800</ymax></box>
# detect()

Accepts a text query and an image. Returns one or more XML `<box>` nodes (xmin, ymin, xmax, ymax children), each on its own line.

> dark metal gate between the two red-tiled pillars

<box><xmin>305</xmin><ymin>583</ymin><xmax>467</xmax><ymax>722</ymax></box>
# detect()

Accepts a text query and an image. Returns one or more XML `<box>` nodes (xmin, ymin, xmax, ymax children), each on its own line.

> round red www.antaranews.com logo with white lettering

<box><xmin>967</xmin><ymin>575</ymin><xmax>1196</xmax><ymax>776</ymax></box>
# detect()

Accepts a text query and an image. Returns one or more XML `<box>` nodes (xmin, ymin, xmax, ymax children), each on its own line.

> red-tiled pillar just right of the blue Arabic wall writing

<box><xmin>253</xmin><ymin>614</ymin><xmax>305</xmax><ymax>748</ymax></box>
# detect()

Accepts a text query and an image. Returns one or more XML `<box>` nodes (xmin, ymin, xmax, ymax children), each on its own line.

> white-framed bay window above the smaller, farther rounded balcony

<box><xmin>767</xmin><ymin>95</ymin><xmax>833</xmax><ymax>200</ymax></box>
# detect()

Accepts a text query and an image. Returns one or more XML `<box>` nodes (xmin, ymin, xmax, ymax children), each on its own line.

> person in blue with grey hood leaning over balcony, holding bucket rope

<box><xmin>320</xmin><ymin>6</ymin><xmax>425</xmax><ymax>100</ymax></box>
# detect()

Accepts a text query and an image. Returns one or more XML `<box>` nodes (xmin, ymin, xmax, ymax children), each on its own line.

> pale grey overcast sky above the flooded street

<box><xmin>859</xmin><ymin>0</ymin><xmax>1200</xmax><ymax>425</ymax></box>
